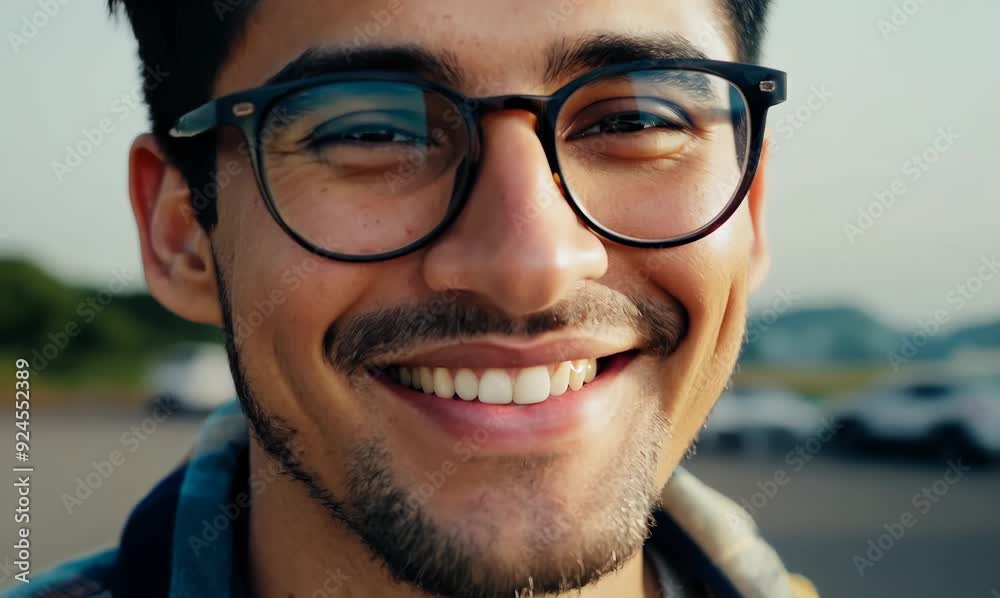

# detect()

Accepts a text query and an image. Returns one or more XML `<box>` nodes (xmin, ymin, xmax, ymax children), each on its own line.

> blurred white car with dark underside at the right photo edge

<box><xmin>831</xmin><ymin>381</ymin><xmax>1000</xmax><ymax>462</ymax></box>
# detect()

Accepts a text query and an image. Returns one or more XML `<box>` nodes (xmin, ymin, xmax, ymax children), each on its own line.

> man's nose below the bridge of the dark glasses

<box><xmin>423</xmin><ymin>110</ymin><xmax>608</xmax><ymax>317</ymax></box>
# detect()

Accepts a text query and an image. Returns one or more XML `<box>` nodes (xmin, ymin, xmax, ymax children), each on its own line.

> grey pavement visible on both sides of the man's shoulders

<box><xmin>0</xmin><ymin>411</ymin><xmax>1000</xmax><ymax>598</ymax></box>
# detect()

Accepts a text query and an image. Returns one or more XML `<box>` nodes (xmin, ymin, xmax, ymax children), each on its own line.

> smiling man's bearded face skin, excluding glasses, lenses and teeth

<box><xmin>203</xmin><ymin>0</ymin><xmax>760</xmax><ymax>595</ymax></box>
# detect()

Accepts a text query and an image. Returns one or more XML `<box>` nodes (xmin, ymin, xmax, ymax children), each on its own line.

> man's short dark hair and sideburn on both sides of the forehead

<box><xmin>108</xmin><ymin>0</ymin><xmax>771</xmax><ymax>231</ymax></box>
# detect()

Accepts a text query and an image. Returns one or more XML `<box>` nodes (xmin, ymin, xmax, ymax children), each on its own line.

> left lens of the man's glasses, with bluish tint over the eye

<box><xmin>260</xmin><ymin>81</ymin><xmax>469</xmax><ymax>255</ymax></box>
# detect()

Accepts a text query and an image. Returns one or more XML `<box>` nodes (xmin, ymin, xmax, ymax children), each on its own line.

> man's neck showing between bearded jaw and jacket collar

<box><xmin>248</xmin><ymin>444</ymin><xmax>660</xmax><ymax>598</ymax></box>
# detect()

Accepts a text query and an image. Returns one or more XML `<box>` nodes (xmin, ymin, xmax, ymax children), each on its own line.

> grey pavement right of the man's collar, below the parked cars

<box><xmin>689</xmin><ymin>452</ymin><xmax>1000</xmax><ymax>598</ymax></box>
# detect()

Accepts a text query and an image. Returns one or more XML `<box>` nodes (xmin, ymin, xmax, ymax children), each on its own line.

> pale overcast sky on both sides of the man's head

<box><xmin>0</xmin><ymin>0</ymin><xmax>1000</xmax><ymax>329</ymax></box>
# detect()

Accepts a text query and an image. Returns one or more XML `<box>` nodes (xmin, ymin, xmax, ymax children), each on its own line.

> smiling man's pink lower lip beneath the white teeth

<box><xmin>378</xmin><ymin>352</ymin><xmax>636</xmax><ymax>454</ymax></box>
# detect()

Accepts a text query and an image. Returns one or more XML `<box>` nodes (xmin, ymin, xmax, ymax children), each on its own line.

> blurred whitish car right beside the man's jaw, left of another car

<box><xmin>699</xmin><ymin>387</ymin><xmax>822</xmax><ymax>452</ymax></box>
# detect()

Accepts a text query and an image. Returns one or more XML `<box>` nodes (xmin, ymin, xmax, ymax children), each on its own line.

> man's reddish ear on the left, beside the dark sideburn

<box><xmin>129</xmin><ymin>133</ymin><xmax>222</xmax><ymax>326</ymax></box>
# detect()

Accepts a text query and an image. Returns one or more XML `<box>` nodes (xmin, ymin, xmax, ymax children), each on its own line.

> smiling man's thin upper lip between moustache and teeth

<box><xmin>379</xmin><ymin>336</ymin><xmax>639</xmax><ymax>369</ymax></box>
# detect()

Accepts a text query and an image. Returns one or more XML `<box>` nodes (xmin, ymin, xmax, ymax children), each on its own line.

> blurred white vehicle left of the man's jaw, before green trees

<box><xmin>148</xmin><ymin>343</ymin><xmax>236</xmax><ymax>413</ymax></box>
